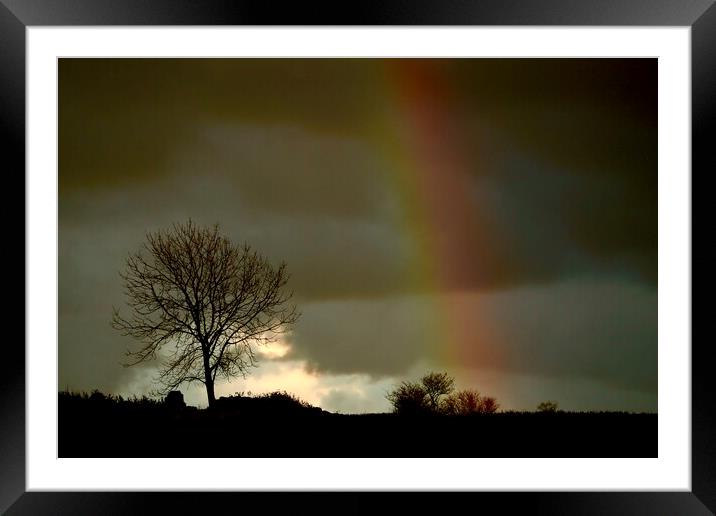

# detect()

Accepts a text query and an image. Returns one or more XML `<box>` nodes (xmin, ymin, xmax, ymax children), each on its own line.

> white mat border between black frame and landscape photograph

<box><xmin>26</xmin><ymin>27</ymin><xmax>691</xmax><ymax>491</ymax></box>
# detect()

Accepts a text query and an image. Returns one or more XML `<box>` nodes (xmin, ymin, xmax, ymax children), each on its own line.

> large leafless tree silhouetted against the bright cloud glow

<box><xmin>112</xmin><ymin>220</ymin><xmax>299</xmax><ymax>406</ymax></box>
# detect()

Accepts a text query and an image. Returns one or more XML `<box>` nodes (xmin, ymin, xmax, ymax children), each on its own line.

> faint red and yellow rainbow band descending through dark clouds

<box><xmin>374</xmin><ymin>59</ymin><xmax>501</xmax><ymax>374</ymax></box>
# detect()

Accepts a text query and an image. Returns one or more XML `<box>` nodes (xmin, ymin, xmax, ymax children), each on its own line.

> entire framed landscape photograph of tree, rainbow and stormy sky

<box><xmin>58</xmin><ymin>57</ymin><xmax>659</xmax><ymax>458</ymax></box>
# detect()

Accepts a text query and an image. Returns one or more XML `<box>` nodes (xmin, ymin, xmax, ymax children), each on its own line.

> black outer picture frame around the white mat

<box><xmin>0</xmin><ymin>0</ymin><xmax>716</xmax><ymax>515</ymax></box>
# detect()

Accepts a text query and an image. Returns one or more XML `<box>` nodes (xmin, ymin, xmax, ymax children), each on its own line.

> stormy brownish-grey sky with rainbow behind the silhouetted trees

<box><xmin>58</xmin><ymin>59</ymin><xmax>658</xmax><ymax>413</ymax></box>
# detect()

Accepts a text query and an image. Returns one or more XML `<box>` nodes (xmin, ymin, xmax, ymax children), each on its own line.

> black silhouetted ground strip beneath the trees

<box><xmin>58</xmin><ymin>394</ymin><xmax>657</xmax><ymax>457</ymax></box>
